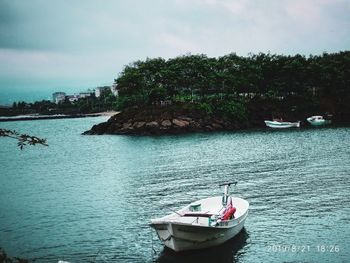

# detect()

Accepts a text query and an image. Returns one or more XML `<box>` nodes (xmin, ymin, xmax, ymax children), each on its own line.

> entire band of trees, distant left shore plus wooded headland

<box><xmin>0</xmin><ymin>51</ymin><xmax>350</xmax><ymax>123</ymax></box>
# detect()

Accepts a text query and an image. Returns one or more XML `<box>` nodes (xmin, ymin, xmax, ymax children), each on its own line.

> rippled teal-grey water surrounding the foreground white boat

<box><xmin>0</xmin><ymin>117</ymin><xmax>350</xmax><ymax>262</ymax></box>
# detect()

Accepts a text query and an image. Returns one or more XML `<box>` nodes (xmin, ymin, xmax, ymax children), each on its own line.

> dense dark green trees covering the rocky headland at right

<box><xmin>115</xmin><ymin>51</ymin><xmax>350</xmax><ymax>119</ymax></box>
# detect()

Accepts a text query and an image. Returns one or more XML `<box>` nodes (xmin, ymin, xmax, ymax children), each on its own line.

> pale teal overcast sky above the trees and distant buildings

<box><xmin>0</xmin><ymin>0</ymin><xmax>350</xmax><ymax>104</ymax></box>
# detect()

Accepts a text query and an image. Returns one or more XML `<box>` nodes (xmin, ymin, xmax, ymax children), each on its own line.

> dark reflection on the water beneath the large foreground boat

<box><xmin>155</xmin><ymin>228</ymin><xmax>249</xmax><ymax>263</ymax></box>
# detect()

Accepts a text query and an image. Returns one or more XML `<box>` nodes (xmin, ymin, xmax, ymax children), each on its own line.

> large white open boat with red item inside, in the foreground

<box><xmin>150</xmin><ymin>183</ymin><xmax>249</xmax><ymax>251</ymax></box>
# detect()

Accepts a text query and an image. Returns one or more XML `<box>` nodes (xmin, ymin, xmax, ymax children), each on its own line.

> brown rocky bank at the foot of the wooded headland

<box><xmin>83</xmin><ymin>104</ymin><xmax>263</xmax><ymax>135</ymax></box>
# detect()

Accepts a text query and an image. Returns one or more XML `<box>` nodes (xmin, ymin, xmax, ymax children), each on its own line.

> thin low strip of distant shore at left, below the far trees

<box><xmin>0</xmin><ymin>111</ymin><xmax>119</xmax><ymax>122</ymax></box>
